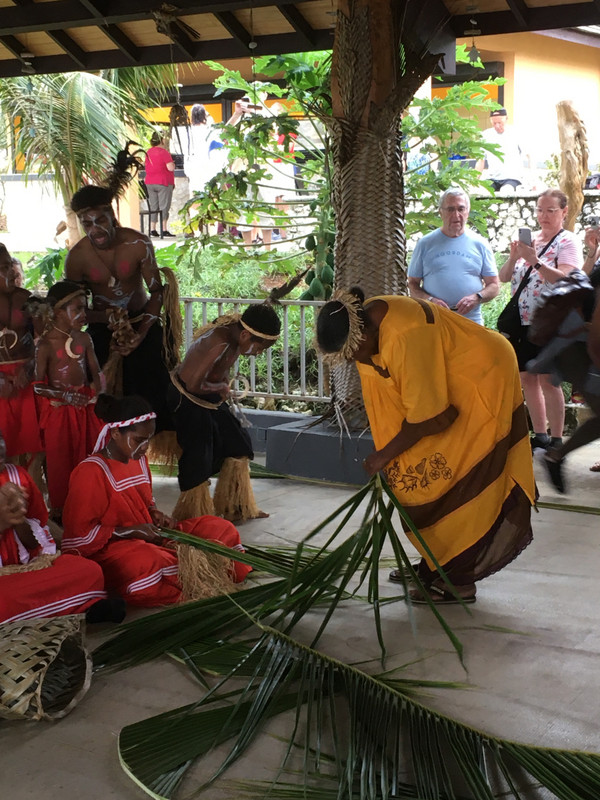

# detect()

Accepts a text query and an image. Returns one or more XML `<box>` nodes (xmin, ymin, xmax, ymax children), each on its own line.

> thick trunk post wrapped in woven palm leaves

<box><xmin>331</xmin><ymin>0</ymin><xmax>439</xmax><ymax>429</ymax></box>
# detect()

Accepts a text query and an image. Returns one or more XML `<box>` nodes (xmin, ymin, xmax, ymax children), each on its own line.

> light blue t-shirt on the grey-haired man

<box><xmin>408</xmin><ymin>228</ymin><xmax>498</xmax><ymax>325</ymax></box>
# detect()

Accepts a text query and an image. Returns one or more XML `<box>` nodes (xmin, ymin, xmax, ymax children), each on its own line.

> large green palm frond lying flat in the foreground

<box><xmin>119</xmin><ymin>630</ymin><xmax>600</xmax><ymax>800</ymax></box>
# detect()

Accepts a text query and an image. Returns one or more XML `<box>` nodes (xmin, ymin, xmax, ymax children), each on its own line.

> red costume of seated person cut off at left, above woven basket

<box><xmin>0</xmin><ymin>464</ymin><xmax>106</xmax><ymax>622</ymax></box>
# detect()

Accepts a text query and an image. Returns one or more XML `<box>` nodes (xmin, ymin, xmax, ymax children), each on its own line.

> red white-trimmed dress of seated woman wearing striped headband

<box><xmin>62</xmin><ymin>455</ymin><xmax>251</xmax><ymax>606</ymax></box>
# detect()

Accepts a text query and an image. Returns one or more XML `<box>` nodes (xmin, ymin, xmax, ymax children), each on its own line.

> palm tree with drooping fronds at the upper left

<box><xmin>0</xmin><ymin>67</ymin><xmax>174</xmax><ymax>244</ymax></box>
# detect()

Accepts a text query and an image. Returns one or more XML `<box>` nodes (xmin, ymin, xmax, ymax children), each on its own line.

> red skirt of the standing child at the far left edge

<box><xmin>0</xmin><ymin>361</ymin><xmax>42</xmax><ymax>458</ymax></box>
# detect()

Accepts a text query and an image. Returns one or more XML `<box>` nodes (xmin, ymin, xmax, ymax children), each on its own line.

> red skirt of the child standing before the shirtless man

<box><xmin>38</xmin><ymin>386</ymin><xmax>103</xmax><ymax>509</ymax></box>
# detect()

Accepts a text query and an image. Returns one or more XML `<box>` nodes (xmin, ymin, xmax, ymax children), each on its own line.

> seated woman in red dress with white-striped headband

<box><xmin>62</xmin><ymin>395</ymin><xmax>250</xmax><ymax>606</ymax></box>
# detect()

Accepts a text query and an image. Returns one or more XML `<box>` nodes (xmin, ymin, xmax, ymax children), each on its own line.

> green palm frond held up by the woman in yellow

<box><xmin>95</xmin><ymin>476</ymin><xmax>462</xmax><ymax>667</ymax></box>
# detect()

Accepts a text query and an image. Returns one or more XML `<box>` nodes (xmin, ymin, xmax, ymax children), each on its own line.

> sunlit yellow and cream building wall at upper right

<box><xmin>459</xmin><ymin>33</ymin><xmax>600</xmax><ymax>168</ymax></box>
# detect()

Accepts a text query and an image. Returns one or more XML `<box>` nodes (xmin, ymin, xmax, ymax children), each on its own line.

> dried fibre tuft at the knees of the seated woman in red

<box><xmin>177</xmin><ymin>543</ymin><xmax>236</xmax><ymax>602</ymax></box>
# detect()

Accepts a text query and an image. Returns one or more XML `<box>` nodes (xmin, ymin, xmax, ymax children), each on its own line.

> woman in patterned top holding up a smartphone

<box><xmin>499</xmin><ymin>189</ymin><xmax>582</xmax><ymax>452</ymax></box>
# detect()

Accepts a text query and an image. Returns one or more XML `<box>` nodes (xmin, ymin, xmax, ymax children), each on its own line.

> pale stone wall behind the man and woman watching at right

<box><xmin>406</xmin><ymin>190</ymin><xmax>600</xmax><ymax>253</ymax></box>
